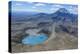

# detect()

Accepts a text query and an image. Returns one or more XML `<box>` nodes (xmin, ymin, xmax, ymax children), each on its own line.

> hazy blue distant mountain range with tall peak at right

<box><xmin>12</xmin><ymin>8</ymin><xmax>78</xmax><ymax>22</ymax></box>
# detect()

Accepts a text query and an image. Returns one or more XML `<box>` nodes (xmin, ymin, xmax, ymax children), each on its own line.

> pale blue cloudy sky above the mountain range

<box><xmin>11</xmin><ymin>1</ymin><xmax>78</xmax><ymax>14</ymax></box>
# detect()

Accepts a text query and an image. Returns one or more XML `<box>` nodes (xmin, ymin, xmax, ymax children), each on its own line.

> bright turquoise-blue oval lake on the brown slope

<box><xmin>22</xmin><ymin>34</ymin><xmax>48</xmax><ymax>46</ymax></box>
